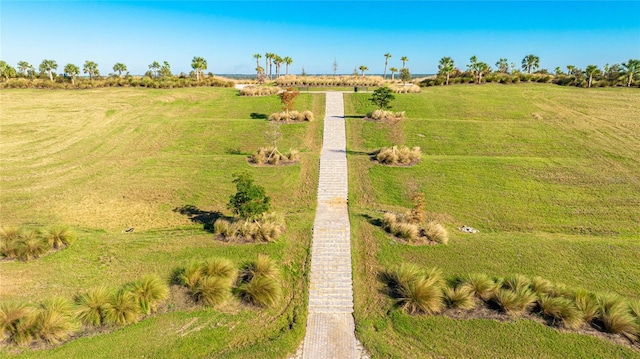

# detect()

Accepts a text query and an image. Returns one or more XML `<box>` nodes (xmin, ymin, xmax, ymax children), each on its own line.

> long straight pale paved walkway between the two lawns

<box><xmin>302</xmin><ymin>92</ymin><xmax>362</xmax><ymax>359</ymax></box>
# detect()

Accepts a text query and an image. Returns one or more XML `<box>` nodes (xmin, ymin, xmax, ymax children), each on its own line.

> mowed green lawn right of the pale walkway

<box><xmin>345</xmin><ymin>84</ymin><xmax>640</xmax><ymax>358</ymax></box>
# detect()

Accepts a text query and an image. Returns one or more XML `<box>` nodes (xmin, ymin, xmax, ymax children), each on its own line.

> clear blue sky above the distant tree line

<box><xmin>0</xmin><ymin>0</ymin><xmax>640</xmax><ymax>74</ymax></box>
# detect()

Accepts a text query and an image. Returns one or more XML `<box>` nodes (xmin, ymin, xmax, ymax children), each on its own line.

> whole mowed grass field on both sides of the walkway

<box><xmin>0</xmin><ymin>84</ymin><xmax>640</xmax><ymax>358</ymax></box>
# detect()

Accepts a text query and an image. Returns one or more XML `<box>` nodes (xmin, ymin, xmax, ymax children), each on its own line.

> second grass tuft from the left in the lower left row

<box><xmin>35</xmin><ymin>298</ymin><xmax>80</xmax><ymax>344</ymax></box>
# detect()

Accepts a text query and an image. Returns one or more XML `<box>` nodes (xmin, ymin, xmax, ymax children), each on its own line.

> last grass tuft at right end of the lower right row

<box><xmin>597</xmin><ymin>294</ymin><xmax>638</xmax><ymax>340</ymax></box>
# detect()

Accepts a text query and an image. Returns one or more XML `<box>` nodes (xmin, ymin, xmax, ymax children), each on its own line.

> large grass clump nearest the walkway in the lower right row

<box><xmin>384</xmin><ymin>264</ymin><xmax>445</xmax><ymax>314</ymax></box>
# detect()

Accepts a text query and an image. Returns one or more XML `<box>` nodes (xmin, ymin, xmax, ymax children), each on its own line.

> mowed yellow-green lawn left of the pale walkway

<box><xmin>0</xmin><ymin>88</ymin><xmax>324</xmax><ymax>358</ymax></box>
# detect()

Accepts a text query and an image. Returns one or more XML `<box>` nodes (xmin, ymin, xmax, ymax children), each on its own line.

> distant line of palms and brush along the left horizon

<box><xmin>0</xmin><ymin>56</ymin><xmax>234</xmax><ymax>88</ymax></box>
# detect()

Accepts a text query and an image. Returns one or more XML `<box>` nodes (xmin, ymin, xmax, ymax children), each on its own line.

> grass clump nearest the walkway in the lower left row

<box><xmin>237</xmin><ymin>254</ymin><xmax>282</xmax><ymax>307</ymax></box>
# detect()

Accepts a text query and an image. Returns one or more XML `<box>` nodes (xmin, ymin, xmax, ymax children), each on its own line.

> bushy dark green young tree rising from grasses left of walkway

<box><xmin>227</xmin><ymin>172</ymin><xmax>271</xmax><ymax>219</ymax></box>
